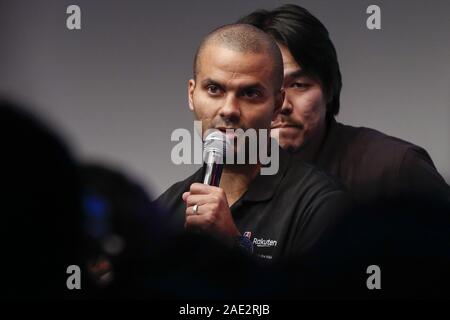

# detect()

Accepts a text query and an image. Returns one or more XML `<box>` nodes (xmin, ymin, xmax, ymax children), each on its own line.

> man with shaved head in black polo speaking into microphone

<box><xmin>158</xmin><ymin>25</ymin><xmax>348</xmax><ymax>259</ymax></box>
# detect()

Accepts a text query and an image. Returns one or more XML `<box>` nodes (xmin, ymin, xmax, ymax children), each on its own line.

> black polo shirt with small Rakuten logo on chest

<box><xmin>157</xmin><ymin>149</ymin><xmax>349</xmax><ymax>260</ymax></box>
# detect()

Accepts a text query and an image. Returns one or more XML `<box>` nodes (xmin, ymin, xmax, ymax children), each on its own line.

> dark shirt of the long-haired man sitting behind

<box><xmin>297</xmin><ymin>119</ymin><xmax>450</xmax><ymax>204</ymax></box>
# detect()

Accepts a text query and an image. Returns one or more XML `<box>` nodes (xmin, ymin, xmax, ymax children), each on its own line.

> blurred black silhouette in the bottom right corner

<box><xmin>286</xmin><ymin>197</ymin><xmax>450</xmax><ymax>299</ymax></box>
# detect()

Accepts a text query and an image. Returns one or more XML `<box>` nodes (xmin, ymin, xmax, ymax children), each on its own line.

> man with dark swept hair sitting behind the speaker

<box><xmin>239</xmin><ymin>5</ymin><xmax>450</xmax><ymax>203</ymax></box>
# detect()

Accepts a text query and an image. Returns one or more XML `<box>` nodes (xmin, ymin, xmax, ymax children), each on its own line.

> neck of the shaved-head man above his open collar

<box><xmin>220</xmin><ymin>164</ymin><xmax>261</xmax><ymax>207</ymax></box>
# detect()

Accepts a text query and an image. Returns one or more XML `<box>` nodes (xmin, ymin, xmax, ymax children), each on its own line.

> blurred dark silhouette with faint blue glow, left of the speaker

<box><xmin>79</xmin><ymin>163</ymin><xmax>169</xmax><ymax>295</ymax></box>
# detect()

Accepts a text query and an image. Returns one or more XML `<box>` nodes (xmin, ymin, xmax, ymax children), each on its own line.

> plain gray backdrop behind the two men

<box><xmin>0</xmin><ymin>0</ymin><xmax>450</xmax><ymax>195</ymax></box>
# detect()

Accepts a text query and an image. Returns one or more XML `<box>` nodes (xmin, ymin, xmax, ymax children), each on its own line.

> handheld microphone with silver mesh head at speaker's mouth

<box><xmin>203</xmin><ymin>130</ymin><xmax>231</xmax><ymax>187</ymax></box>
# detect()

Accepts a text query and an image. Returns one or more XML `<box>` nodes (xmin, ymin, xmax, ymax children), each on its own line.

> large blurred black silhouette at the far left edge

<box><xmin>0</xmin><ymin>97</ymin><xmax>83</xmax><ymax>299</ymax></box>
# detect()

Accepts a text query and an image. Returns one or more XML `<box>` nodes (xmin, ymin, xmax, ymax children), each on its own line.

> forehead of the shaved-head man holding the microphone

<box><xmin>197</xmin><ymin>45</ymin><xmax>274</xmax><ymax>88</ymax></box>
